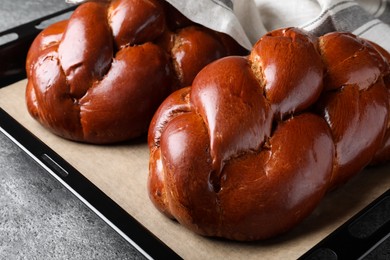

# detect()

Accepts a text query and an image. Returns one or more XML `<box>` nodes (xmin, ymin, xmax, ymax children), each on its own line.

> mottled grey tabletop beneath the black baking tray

<box><xmin>0</xmin><ymin>0</ymin><xmax>144</xmax><ymax>259</ymax></box>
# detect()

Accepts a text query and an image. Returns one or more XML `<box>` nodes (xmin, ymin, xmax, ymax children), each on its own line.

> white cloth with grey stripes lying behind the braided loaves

<box><xmin>65</xmin><ymin>0</ymin><xmax>390</xmax><ymax>52</ymax></box>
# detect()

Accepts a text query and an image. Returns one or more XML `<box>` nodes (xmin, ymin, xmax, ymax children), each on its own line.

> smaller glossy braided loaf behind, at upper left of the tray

<box><xmin>26</xmin><ymin>0</ymin><xmax>245</xmax><ymax>144</ymax></box>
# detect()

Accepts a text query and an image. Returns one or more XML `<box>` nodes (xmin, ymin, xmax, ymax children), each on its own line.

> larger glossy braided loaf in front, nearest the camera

<box><xmin>148</xmin><ymin>28</ymin><xmax>390</xmax><ymax>241</ymax></box>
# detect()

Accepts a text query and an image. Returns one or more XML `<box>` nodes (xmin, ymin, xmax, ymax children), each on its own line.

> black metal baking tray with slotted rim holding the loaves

<box><xmin>0</xmin><ymin>6</ymin><xmax>390</xmax><ymax>259</ymax></box>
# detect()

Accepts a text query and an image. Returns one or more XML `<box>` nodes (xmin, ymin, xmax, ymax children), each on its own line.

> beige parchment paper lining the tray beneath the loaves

<box><xmin>0</xmin><ymin>80</ymin><xmax>390</xmax><ymax>259</ymax></box>
